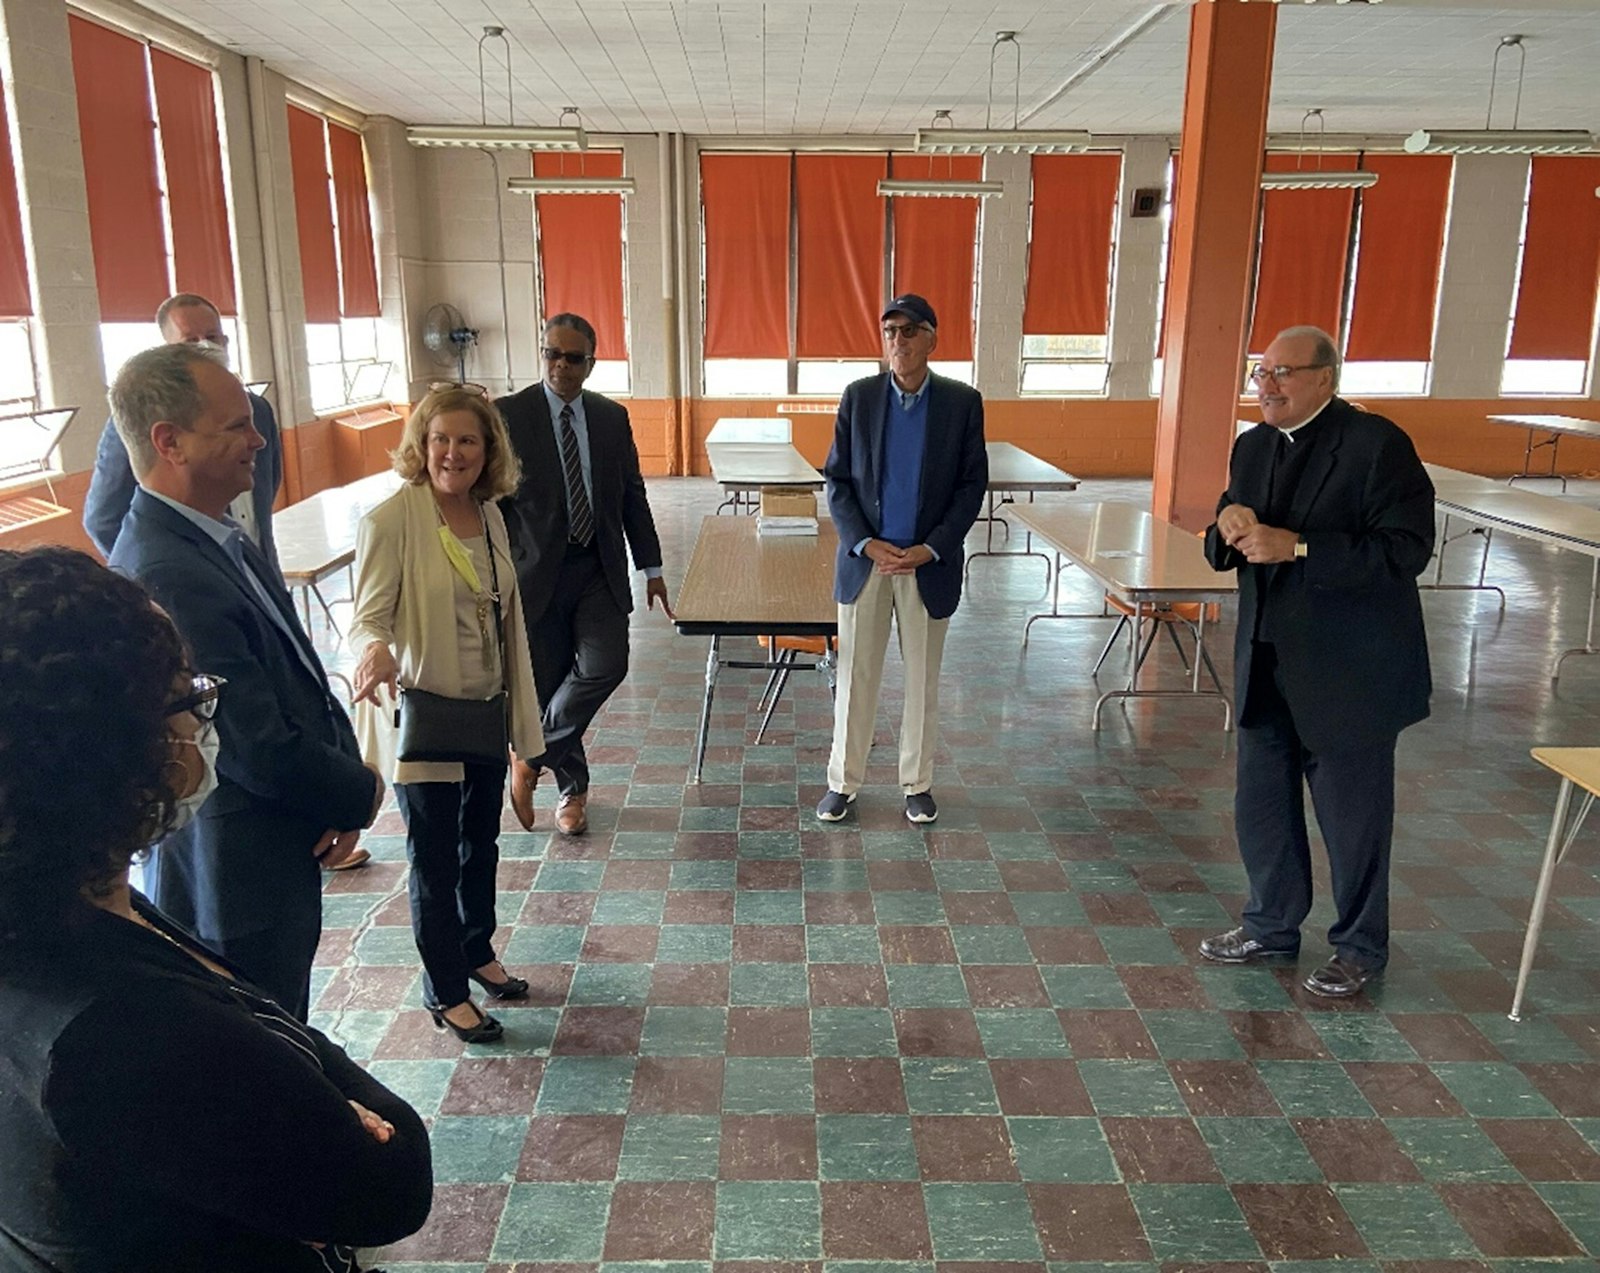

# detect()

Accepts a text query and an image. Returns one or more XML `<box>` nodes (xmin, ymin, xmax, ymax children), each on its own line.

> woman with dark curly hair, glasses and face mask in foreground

<box><xmin>0</xmin><ymin>549</ymin><xmax>432</xmax><ymax>1273</ymax></box>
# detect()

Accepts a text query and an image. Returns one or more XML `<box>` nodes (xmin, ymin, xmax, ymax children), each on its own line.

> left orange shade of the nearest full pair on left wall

<box><xmin>67</xmin><ymin>14</ymin><xmax>170</xmax><ymax>323</ymax></box>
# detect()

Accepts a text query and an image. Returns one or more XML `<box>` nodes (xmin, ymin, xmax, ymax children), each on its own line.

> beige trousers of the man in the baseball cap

<box><xmin>827</xmin><ymin>571</ymin><xmax>950</xmax><ymax>795</ymax></box>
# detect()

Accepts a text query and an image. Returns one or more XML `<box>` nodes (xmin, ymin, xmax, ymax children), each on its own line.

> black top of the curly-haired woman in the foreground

<box><xmin>0</xmin><ymin>899</ymin><xmax>432</xmax><ymax>1273</ymax></box>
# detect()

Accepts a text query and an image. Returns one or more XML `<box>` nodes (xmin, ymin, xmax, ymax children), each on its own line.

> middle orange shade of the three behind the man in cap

<box><xmin>795</xmin><ymin>155</ymin><xmax>888</xmax><ymax>358</ymax></box>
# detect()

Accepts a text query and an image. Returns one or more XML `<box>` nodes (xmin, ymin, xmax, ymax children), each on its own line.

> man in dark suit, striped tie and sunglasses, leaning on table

<box><xmin>496</xmin><ymin>313</ymin><xmax>672</xmax><ymax>835</ymax></box>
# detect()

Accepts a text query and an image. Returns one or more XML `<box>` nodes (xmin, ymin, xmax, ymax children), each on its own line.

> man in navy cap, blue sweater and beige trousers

<box><xmin>816</xmin><ymin>294</ymin><xmax>989</xmax><ymax>822</ymax></box>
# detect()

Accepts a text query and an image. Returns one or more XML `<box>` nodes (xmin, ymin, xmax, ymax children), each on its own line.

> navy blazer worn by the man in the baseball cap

<box><xmin>822</xmin><ymin>371</ymin><xmax>989</xmax><ymax>619</ymax></box>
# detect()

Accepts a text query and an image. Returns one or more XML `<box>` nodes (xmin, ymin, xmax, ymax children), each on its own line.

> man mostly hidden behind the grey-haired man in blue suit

<box><xmin>83</xmin><ymin>291</ymin><xmax>283</xmax><ymax>573</ymax></box>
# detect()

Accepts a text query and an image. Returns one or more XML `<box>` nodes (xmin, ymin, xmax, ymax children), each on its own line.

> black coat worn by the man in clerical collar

<box><xmin>1205</xmin><ymin>398</ymin><xmax>1434</xmax><ymax>750</ymax></box>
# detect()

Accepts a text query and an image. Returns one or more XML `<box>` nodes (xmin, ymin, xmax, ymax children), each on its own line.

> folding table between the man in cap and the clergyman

<box><xmin>1016</xmin><ymin>502</ymin><xmax>1238</xmax><ymax>729</ymax></box>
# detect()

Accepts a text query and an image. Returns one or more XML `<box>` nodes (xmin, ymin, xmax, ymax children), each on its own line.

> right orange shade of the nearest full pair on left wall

<box><xmin>150</xmin><ymin>48</ymin><xmax>238</xmax><ymax>313</ymax></box>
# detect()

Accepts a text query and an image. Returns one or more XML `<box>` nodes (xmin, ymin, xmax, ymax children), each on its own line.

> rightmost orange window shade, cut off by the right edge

<box><xmin>1507</xmin><ymin>155</ymin><xmax>1600</xmax><ymax>361</ymax></box>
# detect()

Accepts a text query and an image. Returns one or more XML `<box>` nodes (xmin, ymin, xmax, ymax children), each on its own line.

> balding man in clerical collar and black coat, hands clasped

<box><xmin>1200</xmin><ymin>328</ymin><xmax>1434</xmax><ymax>998</ymax></box>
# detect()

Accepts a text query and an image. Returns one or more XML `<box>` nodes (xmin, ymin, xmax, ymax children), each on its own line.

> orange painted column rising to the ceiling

<box><xmin>1152</xmin><ymin>0</ymin><xmax>1278</xmax><ymax>531</ymax></box>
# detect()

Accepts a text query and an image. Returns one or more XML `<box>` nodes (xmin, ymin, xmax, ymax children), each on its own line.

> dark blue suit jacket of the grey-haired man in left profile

<box><xmin>110</xmin><ymin>488</ymin><xmax>378</xmax><ymax>940</ymax></box>
